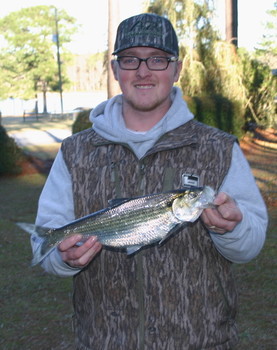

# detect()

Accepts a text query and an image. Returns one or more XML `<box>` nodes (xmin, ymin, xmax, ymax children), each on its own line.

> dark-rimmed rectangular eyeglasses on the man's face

<box><xmin>116</xmin><ymin>56</ymin><xmax>178</xmax><ymax>70</ymax></box>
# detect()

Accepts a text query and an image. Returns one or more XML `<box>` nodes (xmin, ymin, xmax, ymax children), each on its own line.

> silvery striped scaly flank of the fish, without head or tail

<box><xmin>56</xmin><ymin>194</ymin><xmax>179</xmax><ymax>246</ymax></box>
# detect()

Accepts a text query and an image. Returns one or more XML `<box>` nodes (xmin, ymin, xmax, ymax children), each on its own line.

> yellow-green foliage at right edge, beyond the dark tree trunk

<box><xmin>238</xmin><ymin>1</ymin><xmax>277</xmax><ymax>128</ymax></box>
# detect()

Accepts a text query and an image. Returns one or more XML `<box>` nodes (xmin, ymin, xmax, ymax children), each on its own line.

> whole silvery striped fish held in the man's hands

<box><xmin>17</xmin><ymin>186</ymin><xmax>215</xmax><ymax>265</ymax></box>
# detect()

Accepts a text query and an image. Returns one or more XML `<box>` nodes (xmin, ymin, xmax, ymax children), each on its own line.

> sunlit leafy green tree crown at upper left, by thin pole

<box><xmin>0</xmin><ymin>6</ymin><xmax>77</xmax><ymax>110</ymax></box>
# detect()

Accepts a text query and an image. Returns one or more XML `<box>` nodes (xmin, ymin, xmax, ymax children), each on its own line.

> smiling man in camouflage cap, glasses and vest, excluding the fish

<box><xmin>32</xmin><ymin>14</ymin><xmax>267</xmax><ymax>350</ymax></box>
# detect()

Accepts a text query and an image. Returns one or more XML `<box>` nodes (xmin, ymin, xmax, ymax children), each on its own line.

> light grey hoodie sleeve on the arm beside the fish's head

<box><xmin>210</xmin><ymin>144</ymin><xmax>268</xmax><ymax>263</ymax></box>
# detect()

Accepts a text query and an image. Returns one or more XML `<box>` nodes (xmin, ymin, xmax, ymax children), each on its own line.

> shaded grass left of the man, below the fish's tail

<box><xmin>0</xmin><ymin>174</ymin><xmax>73</xmax><ymax>350</ymax></box>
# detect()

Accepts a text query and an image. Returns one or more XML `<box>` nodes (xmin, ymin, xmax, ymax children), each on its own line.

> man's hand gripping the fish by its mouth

<box><xmin>201</xmin><ymin>192</ymin><xmax>242</xmax><ymax>234</ymax></box>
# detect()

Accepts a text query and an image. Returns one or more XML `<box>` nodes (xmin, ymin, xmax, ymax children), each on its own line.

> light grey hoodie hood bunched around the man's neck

<box><xmin>89</xmin><ymin>87</ymin><xmax>193</xmax><ymax>159</ymax></box>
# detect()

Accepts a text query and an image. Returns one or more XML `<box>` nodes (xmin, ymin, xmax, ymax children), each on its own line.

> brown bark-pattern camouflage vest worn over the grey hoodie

<box><xmin>62</xmin><ymin>121</ymin><xmax>237</xmax><ymax>350</ymax></box>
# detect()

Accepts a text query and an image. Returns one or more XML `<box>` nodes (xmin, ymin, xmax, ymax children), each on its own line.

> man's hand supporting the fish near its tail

<box><xmin>58</xmin><ymin>235</ymin><xmax>102</xmax><ymax>268</ymax></box>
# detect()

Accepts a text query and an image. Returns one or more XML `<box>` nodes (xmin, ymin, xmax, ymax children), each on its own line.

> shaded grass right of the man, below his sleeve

<box><xmin>234</xmin><ymin>208</ymin><xmax>277</xmax><ymax>350</ymax></box>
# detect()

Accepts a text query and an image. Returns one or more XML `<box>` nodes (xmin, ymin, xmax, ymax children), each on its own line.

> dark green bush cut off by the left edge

<box><xmin>0</xmin><ymin>125</ymin><xmax>23</xmax><ymax>175</ymax></box>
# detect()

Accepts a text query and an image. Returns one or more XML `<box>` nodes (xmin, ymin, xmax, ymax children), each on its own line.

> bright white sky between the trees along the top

<box><xmin>0</xmin><ymin>0</ymin><xmax>275</xmax><ymax>54</ymax></box>
